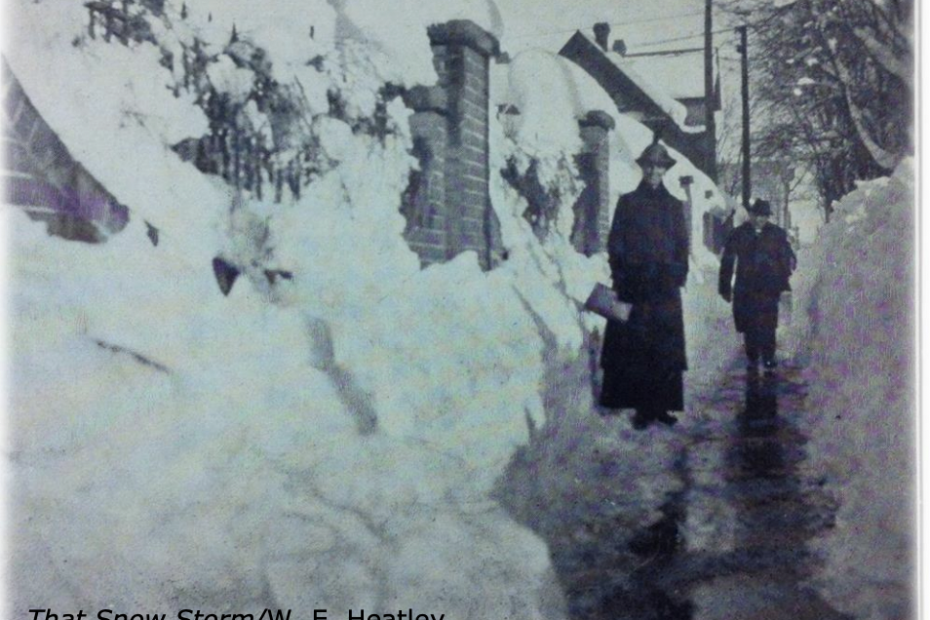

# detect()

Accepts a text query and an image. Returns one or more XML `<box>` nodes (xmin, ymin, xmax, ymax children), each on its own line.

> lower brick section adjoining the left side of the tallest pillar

<box><xmin>401</xmin><ymin>86</ymin><xmax>448</xmax><ymax>267</ymax></box>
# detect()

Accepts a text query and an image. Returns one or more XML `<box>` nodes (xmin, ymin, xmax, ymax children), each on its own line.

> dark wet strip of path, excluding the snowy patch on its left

<box><xmin>553</xmin><ymin>362</ymin><xmax>848</xmax><ymax>620</ymax></box>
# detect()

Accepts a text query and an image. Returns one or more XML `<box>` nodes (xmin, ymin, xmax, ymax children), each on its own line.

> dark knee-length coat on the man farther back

<box><xmin>718</xmin><ymin>222</ymin><xmax>797</xmax><ymax>332</ymax></box>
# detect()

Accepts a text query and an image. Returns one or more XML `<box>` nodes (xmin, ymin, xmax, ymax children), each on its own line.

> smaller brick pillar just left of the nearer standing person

<box><xmin>572</xmin><ymin>110</ymin><xmax>614</xmax><ymax>256</ymax></box>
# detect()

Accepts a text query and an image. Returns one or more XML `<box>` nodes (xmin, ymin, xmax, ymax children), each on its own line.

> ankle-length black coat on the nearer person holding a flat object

<box><xmin>600</xmin><ymin>183</ymin><xmax>688</xmax><ymax>411</ymax></box>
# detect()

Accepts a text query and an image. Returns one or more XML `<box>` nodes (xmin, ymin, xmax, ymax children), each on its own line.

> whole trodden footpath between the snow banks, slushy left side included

<box><xmin>499</xmin><ymin>287</ymin><xmax>850</xmax><ymax>620</ymax></box>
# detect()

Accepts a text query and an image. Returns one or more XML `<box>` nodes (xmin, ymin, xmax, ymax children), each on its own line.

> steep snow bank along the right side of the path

<box><xmin>791</xmin><ymin>161</ymin><xmax>915</xmax><ymax>620</ymax></box>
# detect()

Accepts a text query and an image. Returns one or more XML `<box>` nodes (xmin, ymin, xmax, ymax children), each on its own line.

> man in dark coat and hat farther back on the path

<box><xmin>718</xmin><ymin>200</ymin><xmax>797</xmax><ymax>372</ymax></box>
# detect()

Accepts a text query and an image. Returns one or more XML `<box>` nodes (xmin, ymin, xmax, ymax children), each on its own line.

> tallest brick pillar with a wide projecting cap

<box><xmin>428</xmin><ymin>20</ymin><xmax>499</xmax><ymax>269</ymax></box>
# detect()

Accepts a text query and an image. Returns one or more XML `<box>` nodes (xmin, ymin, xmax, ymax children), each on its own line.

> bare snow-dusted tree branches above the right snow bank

<box><xmin>723</xmin><ymin>0</ymin><xmax>914</xmax><ymax>219</ymax></box>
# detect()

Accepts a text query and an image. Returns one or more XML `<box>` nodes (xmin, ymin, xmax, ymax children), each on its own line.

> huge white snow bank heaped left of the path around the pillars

<box><xmin>4</xmin><ymin>0</ymin><xmax>728</xmax><ymax>620</ymax></box>
